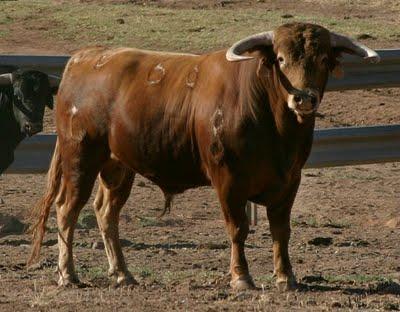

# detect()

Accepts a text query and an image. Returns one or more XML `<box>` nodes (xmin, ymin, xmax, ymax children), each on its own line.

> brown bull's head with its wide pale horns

<box><xmin>226</xmin><ymin>23</ymin><xmax>380</xmax><ymax>121</ymax></box>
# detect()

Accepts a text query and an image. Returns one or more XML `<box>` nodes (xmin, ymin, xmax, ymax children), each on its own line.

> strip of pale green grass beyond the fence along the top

<box><xmin>0</xmin><ymin>0</ymin><xmax>398</xmax><ymax>52</ymax></box>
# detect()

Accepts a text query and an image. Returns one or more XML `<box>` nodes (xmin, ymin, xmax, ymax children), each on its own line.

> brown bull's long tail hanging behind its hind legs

<box><xmin>27</xmin><ymin>139</ymin><xmax>62</xmax><ymax>266</ymax></box>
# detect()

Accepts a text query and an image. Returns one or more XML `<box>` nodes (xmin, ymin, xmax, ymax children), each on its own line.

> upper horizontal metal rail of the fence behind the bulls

<box><xmin>0</xmin><ymin>49</ymin><xmax>400</xmax><ymax>91</ymax></box>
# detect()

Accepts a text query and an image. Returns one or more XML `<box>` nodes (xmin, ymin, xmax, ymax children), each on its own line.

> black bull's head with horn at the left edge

<box><xmin>0</xmin><ymin>70</ymin><xmax>59</xmax><ymax>136</ymax></box>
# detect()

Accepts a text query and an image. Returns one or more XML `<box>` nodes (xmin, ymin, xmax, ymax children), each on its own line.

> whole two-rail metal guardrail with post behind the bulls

<box><xmin>0</xmin><ymin>49</ymin><xmax>400</xmax><ymax>225</ymax></box>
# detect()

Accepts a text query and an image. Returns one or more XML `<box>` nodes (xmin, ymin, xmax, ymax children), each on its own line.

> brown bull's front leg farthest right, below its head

<box><xmin>267</xmin><ymin>179</ymin><xmax>300</xmax><ymax>291</ymax></box>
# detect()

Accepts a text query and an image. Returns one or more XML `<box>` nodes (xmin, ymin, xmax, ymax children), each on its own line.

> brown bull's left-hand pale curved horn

<box><xmin>226</xmin><ymin>31</ymin><xmax>274</xmax><ymax>62</ymax></box>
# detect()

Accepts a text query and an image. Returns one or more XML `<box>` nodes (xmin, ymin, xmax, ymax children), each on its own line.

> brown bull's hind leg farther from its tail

<box><xmin>94</xmin><ymin>160</ymin><xmax>136</xmax><ymax>286</ymax></box>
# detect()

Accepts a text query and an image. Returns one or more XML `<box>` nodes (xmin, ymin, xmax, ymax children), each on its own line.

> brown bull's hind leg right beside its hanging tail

<box><xmin>56</xmin><ymin>142</ymin><xmax>102</xmax><ymax>286</ymax></box>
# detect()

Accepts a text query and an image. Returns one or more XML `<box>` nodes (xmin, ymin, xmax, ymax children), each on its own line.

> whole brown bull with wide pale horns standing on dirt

<box><xmin>30</xmin><ymin>23</ymin><xmax>379</xmax><ymax>289</ymax></box>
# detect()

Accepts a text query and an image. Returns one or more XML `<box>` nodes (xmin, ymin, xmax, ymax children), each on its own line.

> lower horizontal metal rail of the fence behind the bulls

<box><xmin>7</xmin><ymin>125</ymin><xmax>400</xmax><ymax>173</ymax></box>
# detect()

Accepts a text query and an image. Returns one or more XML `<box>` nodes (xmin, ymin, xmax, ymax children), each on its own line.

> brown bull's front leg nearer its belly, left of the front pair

<box><xmin>217</xmin><ymin>180</ymin><xmax>255</xmax><ymax>290</ymax></box>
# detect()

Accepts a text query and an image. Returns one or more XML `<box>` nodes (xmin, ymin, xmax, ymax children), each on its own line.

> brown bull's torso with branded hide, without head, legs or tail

<box><xmin>57</xmin><ymin>44</ymin><xmax>313</xmax><ymax>199</ymax></box>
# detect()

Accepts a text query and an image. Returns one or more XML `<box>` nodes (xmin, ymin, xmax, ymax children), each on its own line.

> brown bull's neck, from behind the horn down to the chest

<box><xmin>238</xmin><ymin>62</ymin><xmax>315</xmax><ymax>168</ymax></box>
